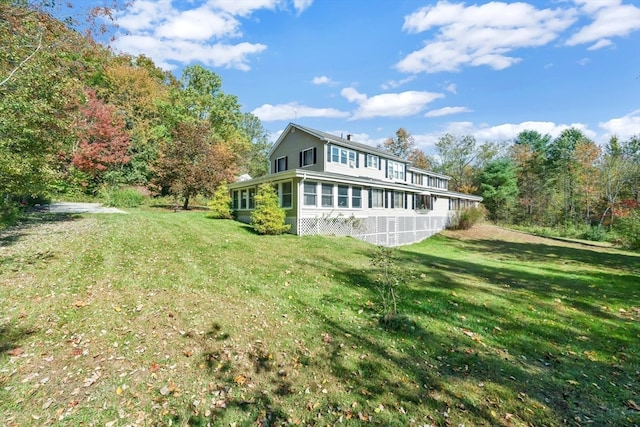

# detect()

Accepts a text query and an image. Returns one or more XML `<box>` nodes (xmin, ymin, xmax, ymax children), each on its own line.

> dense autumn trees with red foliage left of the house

<box><xmin>0</xmin><ymin>0</ymin><xmax>269</xmax><ymax>214</ymax></box>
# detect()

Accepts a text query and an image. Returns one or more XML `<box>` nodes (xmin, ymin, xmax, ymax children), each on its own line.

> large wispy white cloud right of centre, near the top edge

<box><xmin>396</xmin><ymin>1</ymin><xmax>576</xmax><ymax>73</ymax></box>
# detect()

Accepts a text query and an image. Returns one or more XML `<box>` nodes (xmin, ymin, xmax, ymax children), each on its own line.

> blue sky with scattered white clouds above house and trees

<box><xmin>102</xmin><ymin>0</ymin><xmax>640</xmax><ymax>153</ymax></box>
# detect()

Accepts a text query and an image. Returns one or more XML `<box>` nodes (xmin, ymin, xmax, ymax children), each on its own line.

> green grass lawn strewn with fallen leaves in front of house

<box><xmin>0</xmin><ymin>209</ymin><xmax>640</xmax><ymax>426</ymax></box>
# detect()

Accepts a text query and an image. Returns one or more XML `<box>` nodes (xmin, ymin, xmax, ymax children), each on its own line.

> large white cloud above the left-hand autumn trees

<box><xmin>112</xmin><ymin>0</ymin><xmax>313</xmax><ymax>71</ymax></box>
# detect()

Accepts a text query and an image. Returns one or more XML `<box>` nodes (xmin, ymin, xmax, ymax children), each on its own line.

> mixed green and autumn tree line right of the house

<box><xmin>380</xmin><ymin>128</ymin><xmax>640</xmax><ymax>247</ymax></box>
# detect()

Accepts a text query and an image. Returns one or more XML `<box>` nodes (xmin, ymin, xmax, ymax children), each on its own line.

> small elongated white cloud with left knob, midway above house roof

<box><xmin>340</xmin><ymin>87</ymin><xmax>444</xmax><ymax>120</ymax></box>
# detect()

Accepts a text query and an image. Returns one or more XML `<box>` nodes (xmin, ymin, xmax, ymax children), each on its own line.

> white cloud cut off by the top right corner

<box><xmin>567</xmin><ymin>0</ymin><xmax>640</xmax><ymax>48</ymax></box>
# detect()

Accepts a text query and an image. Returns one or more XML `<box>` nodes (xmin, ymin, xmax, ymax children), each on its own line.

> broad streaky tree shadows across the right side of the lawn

<box><xmin>300</xmin><ymin>240</ymin><xmax>640</xmax><ymax>425</ymax></box>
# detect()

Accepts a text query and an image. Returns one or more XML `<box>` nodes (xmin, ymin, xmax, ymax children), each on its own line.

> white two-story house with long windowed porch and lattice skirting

<box><xmin>229</xmin><ymin>123</ymin><xmax>482</xmax><ymax>246</ymax></box>
